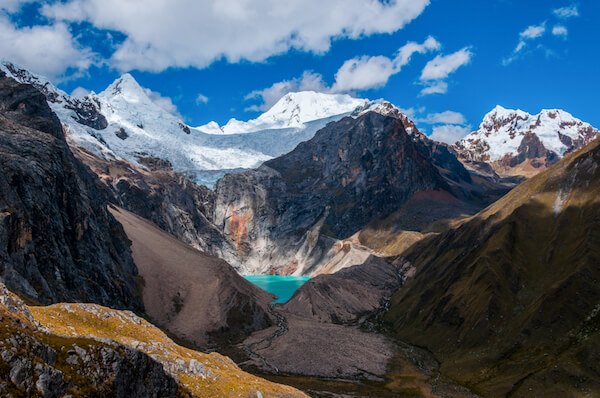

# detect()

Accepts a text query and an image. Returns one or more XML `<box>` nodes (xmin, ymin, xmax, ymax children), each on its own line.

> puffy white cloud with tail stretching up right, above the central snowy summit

<box><xmin>331</xmin><ymin>37</ymin><xmax>441</xmax><ymax>92</ymax></box>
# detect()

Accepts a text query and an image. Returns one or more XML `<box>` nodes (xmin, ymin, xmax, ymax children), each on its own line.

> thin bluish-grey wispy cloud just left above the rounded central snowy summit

<box><xmin>246</xmin><ymin>71</ymin><xmax>329</xmax><ymax>111</ymax></box>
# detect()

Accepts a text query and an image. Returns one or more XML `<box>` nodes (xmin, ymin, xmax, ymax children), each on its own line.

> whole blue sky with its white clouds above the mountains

<box><xmin>0</xmin><ymin>0</ymin><xmax>600</xmax><ymax>143</ymax></box>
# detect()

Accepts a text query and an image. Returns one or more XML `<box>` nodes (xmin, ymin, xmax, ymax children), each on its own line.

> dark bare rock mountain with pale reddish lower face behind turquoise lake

<box><xmin>212</xmin><ymin>111</ymin><xmax>504</xmax><ymax>274</ymax></box>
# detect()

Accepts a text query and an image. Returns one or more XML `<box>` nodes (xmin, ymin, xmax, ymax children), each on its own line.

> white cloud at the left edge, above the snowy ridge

<box><xmin>0</xmin><ymin>15</ymin><xmax>94</xmax><ymax>78</ymax></box>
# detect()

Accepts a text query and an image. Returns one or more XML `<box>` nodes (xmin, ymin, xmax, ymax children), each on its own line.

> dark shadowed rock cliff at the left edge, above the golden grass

<box><xmin>0</xmin><ymin>74</ymin><xmax>142</xmax><ymax>309</ymax></box>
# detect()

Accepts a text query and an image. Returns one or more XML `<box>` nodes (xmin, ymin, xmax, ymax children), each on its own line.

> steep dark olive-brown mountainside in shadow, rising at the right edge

<box><xmin>387</xmin><ymin>140</ymin><xmax>600</xmax><ymax>396</ymax></box>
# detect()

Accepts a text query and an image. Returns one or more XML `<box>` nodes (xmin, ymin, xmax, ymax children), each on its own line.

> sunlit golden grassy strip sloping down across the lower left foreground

<box><xmin>30</xmin><ymin>304</ymin><xmax>305</xmax><ymax>397</ymax></box>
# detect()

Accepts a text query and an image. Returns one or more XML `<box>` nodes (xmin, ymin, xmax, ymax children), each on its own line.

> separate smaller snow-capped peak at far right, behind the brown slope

<box><xmin>454</xmin><ymin>105</ymin><xmax>600</xmax><ymax>176</ymax></box>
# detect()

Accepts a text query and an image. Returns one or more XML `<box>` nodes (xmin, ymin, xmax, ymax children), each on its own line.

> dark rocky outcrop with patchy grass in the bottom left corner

<box><xmin>0</xmin><ymin>284</ymin><xmax>184</xmax><ymax>397</ymax></box>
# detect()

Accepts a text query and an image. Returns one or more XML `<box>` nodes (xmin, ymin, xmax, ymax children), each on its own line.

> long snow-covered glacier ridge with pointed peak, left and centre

<box><xmin>0</xmin><ymin>62</ymin><xmax>376</xmax><ymax>185</ymax></box>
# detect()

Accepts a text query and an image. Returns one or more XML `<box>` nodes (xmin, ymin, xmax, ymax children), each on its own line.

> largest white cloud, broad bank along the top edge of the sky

<box><xmin>42</xmin><ymin>0</ymin><xmax>430</xmax><ymax>71</ymax></box>
